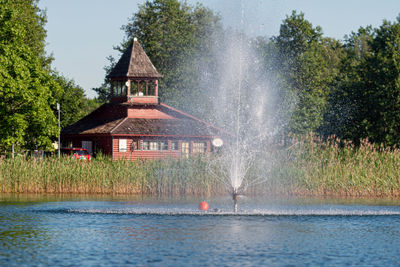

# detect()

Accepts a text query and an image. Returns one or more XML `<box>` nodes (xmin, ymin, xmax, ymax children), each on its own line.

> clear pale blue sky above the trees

<box><xmin>39</xmin><ymin>0</ymin><xmax>400</xmax><ymax>98</ymax></box>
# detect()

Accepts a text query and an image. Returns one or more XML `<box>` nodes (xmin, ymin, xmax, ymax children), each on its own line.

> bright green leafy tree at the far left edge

<box><xmin>0</xmin><ymin>0</ymin><xmax>59</xmax><ymax>152</ymax></box>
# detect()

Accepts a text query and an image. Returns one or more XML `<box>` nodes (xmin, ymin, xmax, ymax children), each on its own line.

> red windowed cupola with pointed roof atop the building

<box><xmin>108</xmin><ymin>38</ymin><xmax>162</xmax><ymax>104</ymax></box>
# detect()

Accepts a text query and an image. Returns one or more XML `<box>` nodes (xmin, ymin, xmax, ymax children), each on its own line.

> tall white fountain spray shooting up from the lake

<box><xmin>206</xmin><ymin>0</ymin><xmax>286</xmax><ymax>212</ymax></box>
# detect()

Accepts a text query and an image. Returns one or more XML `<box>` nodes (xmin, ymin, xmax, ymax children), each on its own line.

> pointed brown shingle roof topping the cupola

<box><xmin>108</xmin><ymin>39</ymin><xmax>162</xmax><ymax>78</ymax></box>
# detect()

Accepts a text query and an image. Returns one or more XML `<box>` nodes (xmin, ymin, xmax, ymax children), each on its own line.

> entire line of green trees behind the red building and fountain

<box><xmin>0</xmin><ymin>0</ymin><xmax>400</xmax><ymax>154</ymax></box>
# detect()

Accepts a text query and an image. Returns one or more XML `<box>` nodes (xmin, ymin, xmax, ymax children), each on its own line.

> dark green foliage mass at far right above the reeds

<box><xmin>326</xmin><ymin>18</ymin><xmax>400</xmax><ymax>146</ymax></box>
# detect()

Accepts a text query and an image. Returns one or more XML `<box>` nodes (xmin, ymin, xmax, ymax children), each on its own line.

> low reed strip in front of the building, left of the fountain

<box><xmin>0</xmin><ymin>157</ymin><xmax>225</xmax><ymax>195</ymax></box>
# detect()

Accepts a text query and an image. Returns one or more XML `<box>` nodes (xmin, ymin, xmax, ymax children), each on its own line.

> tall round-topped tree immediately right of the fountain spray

<box><xmin>272</xmin><ymin>11</ymin><xmax>338</xmax><ymax>133</ymax></box>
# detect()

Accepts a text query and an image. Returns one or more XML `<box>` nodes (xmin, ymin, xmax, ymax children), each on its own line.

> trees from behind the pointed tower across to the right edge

<box><xmin>95</xmin><ymin>0</ymin><xmax>400</xmax><ymax>146</ymax></box>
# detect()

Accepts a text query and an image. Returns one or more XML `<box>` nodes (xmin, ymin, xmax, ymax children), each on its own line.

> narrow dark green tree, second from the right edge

<box><xmin>321</xmin><ymin>26</ymin><xmax>373</xmax><ymax>143</ymax></box>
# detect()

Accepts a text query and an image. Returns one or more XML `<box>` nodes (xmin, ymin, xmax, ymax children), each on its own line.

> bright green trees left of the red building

<box><xmin>0</xmin><ymin>0</ymin><xmax>99</xmax><ymax>153</ymax></box>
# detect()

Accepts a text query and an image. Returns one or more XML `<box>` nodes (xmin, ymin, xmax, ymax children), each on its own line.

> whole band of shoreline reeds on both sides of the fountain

<box><xmin>0</xmin><ymin>134</ymin><xmax>400</xmax><ymax>197</ymax></box>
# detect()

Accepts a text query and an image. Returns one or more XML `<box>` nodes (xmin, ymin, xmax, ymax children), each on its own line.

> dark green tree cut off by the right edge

<box><xmin>359</xmin><ymin>17</ymin><xmax>400</xmax><ymax>145</ymax></box>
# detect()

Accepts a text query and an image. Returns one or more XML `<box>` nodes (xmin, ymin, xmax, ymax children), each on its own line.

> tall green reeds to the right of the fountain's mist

<box><xmin>276</xmin><ymin>134</ymin><xmax>400</xmax><ymax>197</ymax></box>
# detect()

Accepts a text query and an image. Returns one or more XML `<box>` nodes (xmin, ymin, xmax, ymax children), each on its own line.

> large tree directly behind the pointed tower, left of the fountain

<box><xmin>95</xmin><ymin>0</ymin><xmax>222</xmax><ymax>117</ymax></box>
